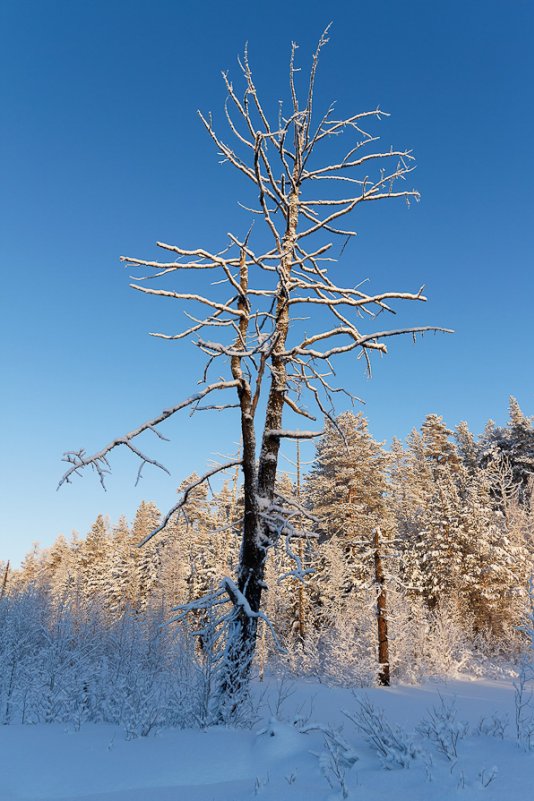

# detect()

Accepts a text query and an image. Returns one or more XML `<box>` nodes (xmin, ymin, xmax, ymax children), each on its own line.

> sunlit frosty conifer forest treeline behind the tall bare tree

<box><xmin>0</xmin><ymin>398</ymin><xmax>534</xmax><ymax>725</ymax></box>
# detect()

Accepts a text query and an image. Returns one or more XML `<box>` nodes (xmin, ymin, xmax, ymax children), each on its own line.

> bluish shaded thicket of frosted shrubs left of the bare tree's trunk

<box><xmin>0</xmin><ymin>589</ymin><xmax>252</xmax><ymax>737</ymax></box>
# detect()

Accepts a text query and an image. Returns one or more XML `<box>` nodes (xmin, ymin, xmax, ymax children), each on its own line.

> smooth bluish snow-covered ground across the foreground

<box><xmin>0</xmin><ymin>680</ymin><xmax>534</xmax><ymax>801</ymax></box>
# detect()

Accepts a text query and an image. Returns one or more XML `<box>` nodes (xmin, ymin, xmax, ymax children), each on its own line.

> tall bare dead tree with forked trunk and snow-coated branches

<box><xmin>60</xmin><ymin>29</ymin><xmax>452</xmax><ymax>698</ymax></box>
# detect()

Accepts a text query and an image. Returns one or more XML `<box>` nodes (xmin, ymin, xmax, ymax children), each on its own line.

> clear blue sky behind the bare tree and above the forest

<box><xmin>0</xmin><ymin>0</ymin><xmax>534</xmax><ymax>562</ymax></box>
